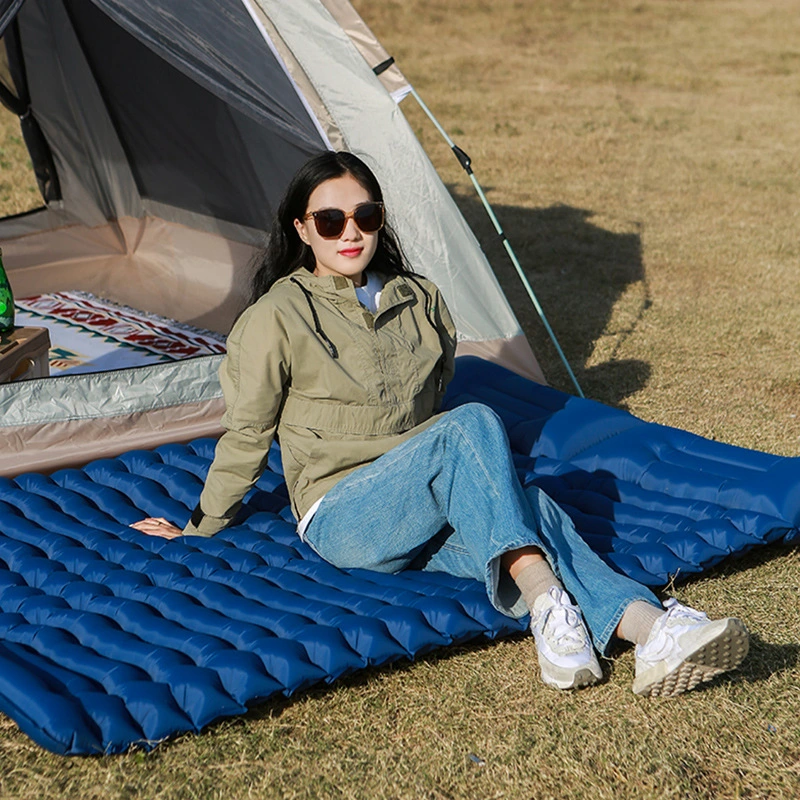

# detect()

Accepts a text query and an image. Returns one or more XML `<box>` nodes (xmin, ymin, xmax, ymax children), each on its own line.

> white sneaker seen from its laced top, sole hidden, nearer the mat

<box><xmin>531</xmin><ymin>586</ymin><xmax>603</xmax><ymax>689</ymax></box>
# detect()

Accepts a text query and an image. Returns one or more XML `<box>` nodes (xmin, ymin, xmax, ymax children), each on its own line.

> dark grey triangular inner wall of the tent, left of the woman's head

<box><xmin>63</xmin><ymin>0</ymin><xmax>290</xmax><ymax>228</ymax></box>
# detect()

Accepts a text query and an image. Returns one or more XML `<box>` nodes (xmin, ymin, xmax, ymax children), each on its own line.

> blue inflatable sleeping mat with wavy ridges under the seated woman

<box><xmin>0</xmin><ymin>358</ymin><xmax>800</xmax><ymax>754</ymax></box>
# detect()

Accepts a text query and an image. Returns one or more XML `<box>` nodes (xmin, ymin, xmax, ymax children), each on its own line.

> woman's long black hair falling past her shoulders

<box><xmin>251</xmin><ymin>151</ymin><xmax>412</xmax><ymax>302</ymax></box>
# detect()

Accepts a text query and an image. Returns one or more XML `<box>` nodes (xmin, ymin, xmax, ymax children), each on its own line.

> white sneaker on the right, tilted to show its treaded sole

<box><xmin>633</xmin><ymin>597</ymin><xmax>750</xmax><ymax>697</ymax></box>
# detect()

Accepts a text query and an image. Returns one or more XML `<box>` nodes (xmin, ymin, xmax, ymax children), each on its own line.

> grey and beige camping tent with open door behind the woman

<box><xmin>0</xmin><ymin>0</ymin><xmax>541</xmax><ymax>474</ymax></box>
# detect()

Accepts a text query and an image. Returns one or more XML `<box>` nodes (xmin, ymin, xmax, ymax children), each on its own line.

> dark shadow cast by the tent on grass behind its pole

<box><xmin>455</xmin><ymin>195</ymin><xmax>651</xmax><ymax>405</ymax></box>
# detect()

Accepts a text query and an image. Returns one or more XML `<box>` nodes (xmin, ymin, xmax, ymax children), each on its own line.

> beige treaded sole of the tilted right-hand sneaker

<box><xmin>633</xmin><ymin>619</ymin><xmax>750</xmax><ymax>697</ymax></box>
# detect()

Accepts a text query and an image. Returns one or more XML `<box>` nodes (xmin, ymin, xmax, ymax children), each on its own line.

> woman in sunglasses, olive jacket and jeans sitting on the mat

<box><xmin>134</xmin><ymin>152</ymin><xmax>748</xmax><ymax>695</ymax></box>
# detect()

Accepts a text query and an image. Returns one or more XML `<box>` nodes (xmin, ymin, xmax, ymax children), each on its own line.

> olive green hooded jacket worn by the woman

<box><xmin>184</xmin><ymin>268</ymin><xmax>456</xmax><ymax>536</ymax></box>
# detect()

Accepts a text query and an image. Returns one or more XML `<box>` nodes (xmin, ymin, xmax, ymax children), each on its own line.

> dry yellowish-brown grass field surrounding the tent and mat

<box><xmin>0</xmin><ymin>0</ymin><xmax>800</xmax><ymax>800</ymax></box>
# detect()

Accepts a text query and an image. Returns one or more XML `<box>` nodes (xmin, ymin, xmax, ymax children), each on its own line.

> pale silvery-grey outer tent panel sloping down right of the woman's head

<box><xmin>258</xmin><ymin>0</ymin><xmax>521</xmax><ymax>341</ymax></box>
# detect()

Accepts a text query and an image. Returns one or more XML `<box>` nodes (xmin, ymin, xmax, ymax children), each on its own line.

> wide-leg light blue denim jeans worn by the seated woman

<box><xmin>304</xmin><ymin>403</ymin><xmax>661</xmax><ymax>653</ymax></box>
